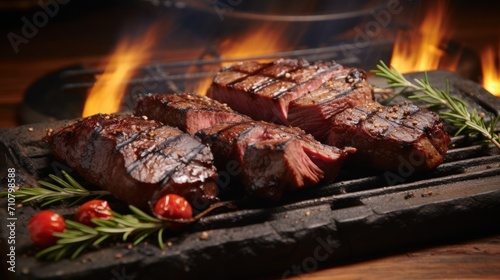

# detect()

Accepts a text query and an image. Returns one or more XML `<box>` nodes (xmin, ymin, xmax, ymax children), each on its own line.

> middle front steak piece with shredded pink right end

<box><xmin>196</xmin><ymin>122</ymin><xmax>355</xmax><ymax>200</ymax></box>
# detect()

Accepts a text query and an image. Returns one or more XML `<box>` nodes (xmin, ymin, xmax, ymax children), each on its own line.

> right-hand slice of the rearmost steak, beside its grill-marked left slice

<box><xmin>288</xmin><ymin>68</ymin><xmax>373</xmax><ymax>142</ymax></box>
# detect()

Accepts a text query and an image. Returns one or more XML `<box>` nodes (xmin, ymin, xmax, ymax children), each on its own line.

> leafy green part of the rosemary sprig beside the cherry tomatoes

<box><xmin>36</xmin><ymin>205</ymin><xmax>167</xmax><ymax>261</ymax></box>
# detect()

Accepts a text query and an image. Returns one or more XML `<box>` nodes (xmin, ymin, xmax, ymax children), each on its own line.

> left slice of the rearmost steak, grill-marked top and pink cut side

<box><xmin>207</xmin><ymin>59</ymin><xmax>342</xmax><ymax>124</ymax></box>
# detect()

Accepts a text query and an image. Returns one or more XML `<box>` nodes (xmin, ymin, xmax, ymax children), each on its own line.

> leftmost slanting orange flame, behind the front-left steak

<box><xmin>82</xmin><ymin>28</ymin><xmax>158</xmax><ymax>117</ymax></box>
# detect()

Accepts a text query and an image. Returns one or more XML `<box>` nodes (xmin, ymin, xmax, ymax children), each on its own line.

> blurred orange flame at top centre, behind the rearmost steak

<box><xmin>194</xmin><ymin>24</ymin><xmax>294</xmax><ymax>95</ymax></box>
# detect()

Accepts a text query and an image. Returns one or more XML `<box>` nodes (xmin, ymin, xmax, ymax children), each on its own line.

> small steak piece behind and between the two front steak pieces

<box><xmin>134</xmin><ymin>93</ymin><xmax>251</xmax><ymax>134</ymax></box>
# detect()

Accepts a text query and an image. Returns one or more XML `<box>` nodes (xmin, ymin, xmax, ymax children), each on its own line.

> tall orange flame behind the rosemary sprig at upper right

<box><xmin>391</xmin><ymin>1</ymin><xmax>454</xmax><ymax>73</ymax></box>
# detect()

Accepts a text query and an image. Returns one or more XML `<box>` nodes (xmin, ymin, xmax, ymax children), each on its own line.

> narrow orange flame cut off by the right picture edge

<box><xmin>481</xmin><ymin>45</ymin><xmax>500</xmax><ymax>96</ymax></box>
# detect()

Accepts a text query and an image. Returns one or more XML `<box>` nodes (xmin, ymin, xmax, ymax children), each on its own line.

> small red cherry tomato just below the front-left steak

<box><xmin>154</xmin><ymin>194</ymin><xmax>193</xmax><ymax>219</ymax></box>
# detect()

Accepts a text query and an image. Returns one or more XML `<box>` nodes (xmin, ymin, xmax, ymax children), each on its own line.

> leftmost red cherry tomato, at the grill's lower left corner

<box><xmin>28</xmin><ymin>210</ymin><xmax>66</xmax><ymax>248</ymax></box>
